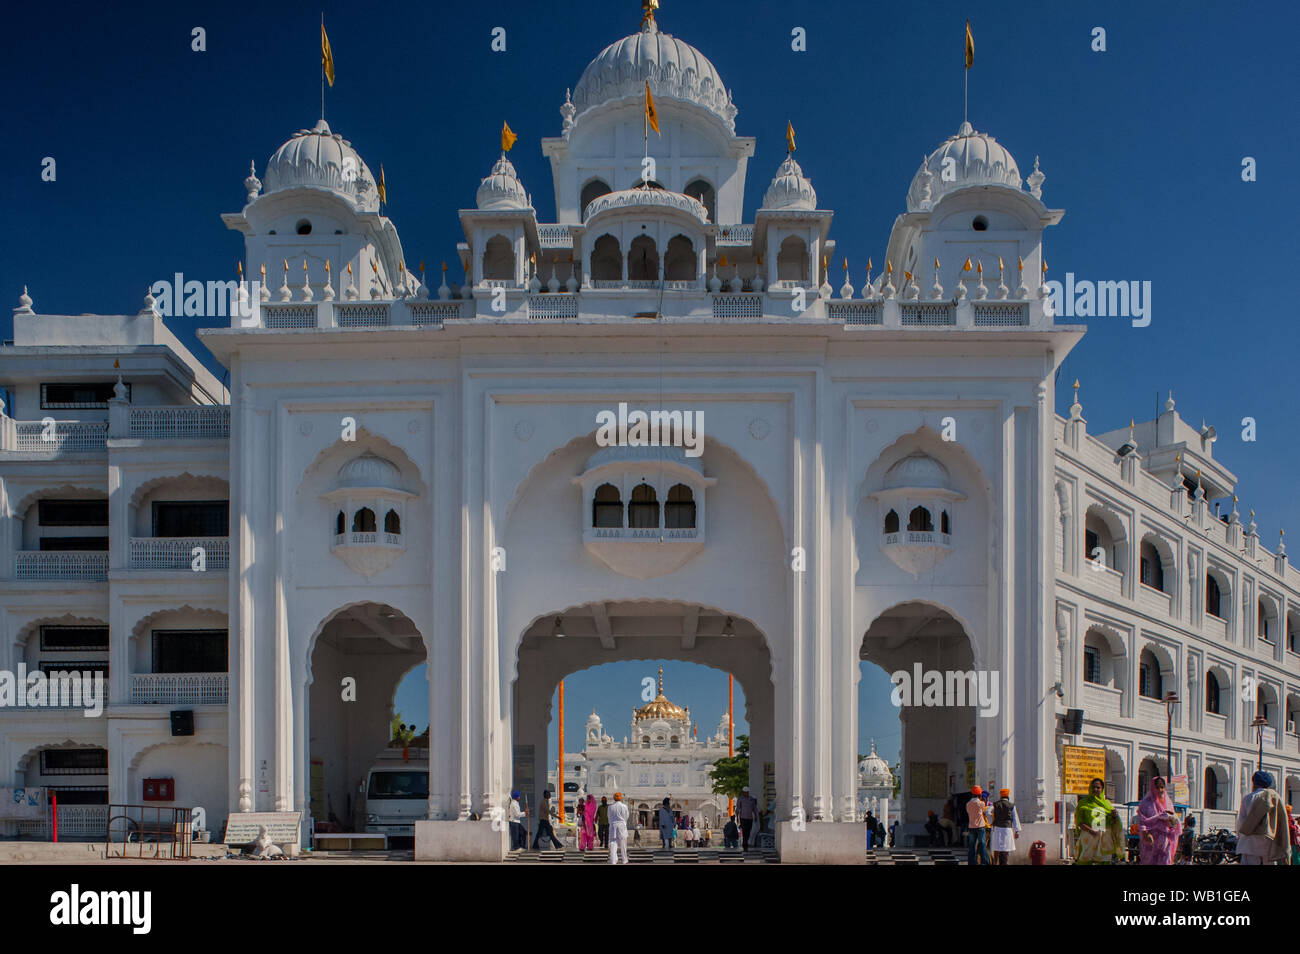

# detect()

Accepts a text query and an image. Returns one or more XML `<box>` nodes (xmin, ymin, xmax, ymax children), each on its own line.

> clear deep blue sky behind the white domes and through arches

<box><xmin>0</xmin><ymin>0</ymin><xmax>1300</xmax><ymax>758</ymax></box>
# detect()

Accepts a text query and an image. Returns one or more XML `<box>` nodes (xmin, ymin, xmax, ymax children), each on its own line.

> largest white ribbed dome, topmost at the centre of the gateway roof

<box><xmin>573</xmin><ymin>19</ymin><xmax>736</xmax><ymax>131</ymax></box>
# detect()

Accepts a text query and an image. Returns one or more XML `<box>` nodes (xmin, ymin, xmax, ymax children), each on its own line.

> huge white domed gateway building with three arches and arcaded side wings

<box><xmin>0</xmin><ymin>3</ymin><xmax>1300</xmax><ymax>860</ymax></box>
